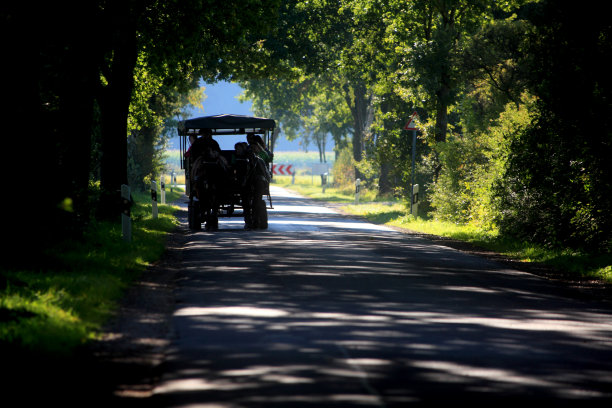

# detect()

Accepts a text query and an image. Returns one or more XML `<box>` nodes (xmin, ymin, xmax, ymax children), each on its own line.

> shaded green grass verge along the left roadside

<box><xmin>0</xmin><ymin>190</ymin><xmax>180</xmax><ymax>356</ymax></box>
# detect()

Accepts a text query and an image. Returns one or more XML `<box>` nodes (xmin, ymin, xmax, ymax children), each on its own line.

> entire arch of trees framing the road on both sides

<box><xmin>1</xmin><ymin>0</ymin><xmax>612</xmax><ymax>251</ymax></box>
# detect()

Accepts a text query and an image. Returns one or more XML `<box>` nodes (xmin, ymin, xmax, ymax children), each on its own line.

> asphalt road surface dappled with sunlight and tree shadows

<box><xmin>150</xmin><ymin>188</ymin><xmax>612</xmax><ymax>408</ymax></box>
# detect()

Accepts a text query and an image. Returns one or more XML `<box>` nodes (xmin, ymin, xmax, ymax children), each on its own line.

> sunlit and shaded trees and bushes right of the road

<box><xmin>245</xmin><ymin>0</ymin><xmax>612</xmax><ymax>251</ymax></box>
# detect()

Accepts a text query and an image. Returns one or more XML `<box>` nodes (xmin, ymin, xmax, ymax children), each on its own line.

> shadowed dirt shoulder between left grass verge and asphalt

<box><xmin>82</xmin><ymin>206</ymin><xmax>190</xmax><ymax>407</ymax></box>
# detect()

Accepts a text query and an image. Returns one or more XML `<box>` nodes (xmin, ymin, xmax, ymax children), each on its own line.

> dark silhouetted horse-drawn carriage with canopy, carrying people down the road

<box><xmin>178</xmin><ymin>115</ymin><xmax>275</xmax><ymax>230</ymax></box>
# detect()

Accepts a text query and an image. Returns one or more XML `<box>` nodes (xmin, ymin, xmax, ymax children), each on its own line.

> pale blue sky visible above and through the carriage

<box><xmin>170</xmin><ymin>82</ymin><xmax>304</xmax><ymax>151</ymax></box>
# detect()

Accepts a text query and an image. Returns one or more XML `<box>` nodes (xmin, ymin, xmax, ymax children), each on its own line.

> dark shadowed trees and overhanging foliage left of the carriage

<box><xmin>0</xmin><ymin>0</ymin><xmax>278</xmax><ymax>245</ymax></box>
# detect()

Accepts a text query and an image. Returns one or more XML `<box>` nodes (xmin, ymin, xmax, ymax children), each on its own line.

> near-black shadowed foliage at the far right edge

<box><xmin>499</xmin><ymin>1</ymin><xmax>612</xmax><ymax>251</ymax></box>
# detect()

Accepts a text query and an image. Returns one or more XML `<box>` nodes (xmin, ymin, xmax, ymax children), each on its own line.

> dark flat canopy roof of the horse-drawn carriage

<box><xmin>178</xmin><ymin>115</ymin><xmax>276</xmax><ymax>135</ymax></box>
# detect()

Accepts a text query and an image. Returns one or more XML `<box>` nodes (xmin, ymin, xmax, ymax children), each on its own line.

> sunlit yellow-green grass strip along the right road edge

<box><xmin>275</xmin><ymin>176</ymin><xmax>612</xmax><ymax>283</ymax></box>
